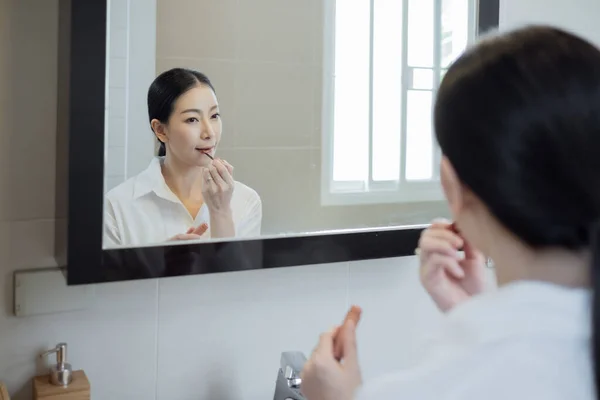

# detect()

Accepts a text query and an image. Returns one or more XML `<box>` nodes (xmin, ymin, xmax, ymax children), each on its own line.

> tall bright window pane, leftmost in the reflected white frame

<box><xmin>333</xmin><ymin>0</ymin><xmax>371</xmax><ymax>181</ymax></box>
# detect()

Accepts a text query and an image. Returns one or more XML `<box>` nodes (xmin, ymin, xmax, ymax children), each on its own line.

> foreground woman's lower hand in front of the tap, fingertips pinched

<box><xmin>301</xmin><ymin>319</ymin><xmax>362</xmax><ymax>400</ymax></box>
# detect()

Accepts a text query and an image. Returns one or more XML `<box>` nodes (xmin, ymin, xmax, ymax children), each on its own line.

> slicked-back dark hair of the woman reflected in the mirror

<box><xmin>148</xmin><ymin>68</ymin><xmax>215</xmax><ymax>156</ymax></box>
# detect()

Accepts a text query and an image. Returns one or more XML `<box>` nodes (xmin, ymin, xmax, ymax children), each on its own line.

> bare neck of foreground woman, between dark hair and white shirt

<box><xmin>489</xmin><ymin>233</ymin><xmax>591</xmax><ymax>287</ymax></box>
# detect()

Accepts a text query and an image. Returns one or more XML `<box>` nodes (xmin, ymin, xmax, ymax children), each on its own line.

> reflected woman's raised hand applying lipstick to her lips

<box><xmin>202</xmin><ymin>158</ymin><xmax>235</xmax><ymax>214</ymax></box>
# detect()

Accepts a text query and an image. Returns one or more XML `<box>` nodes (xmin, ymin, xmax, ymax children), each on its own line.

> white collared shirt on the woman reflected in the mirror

<box><xmin>103</xmin><ymin>157</ymin><xmax>262</xmax><ymax>247</ymax></box>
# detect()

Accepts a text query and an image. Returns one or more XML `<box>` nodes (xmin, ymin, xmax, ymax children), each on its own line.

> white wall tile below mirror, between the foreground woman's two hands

<box><xmin>349</xmin><ymin>257</ymin><xmax>442</xmax><ymax>379</ymax></box>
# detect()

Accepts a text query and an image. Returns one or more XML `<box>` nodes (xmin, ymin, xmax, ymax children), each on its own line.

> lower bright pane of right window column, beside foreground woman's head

<box><xmin>405</xmin><ymin>90</ymin><xmax>433</xmax><ymax>181</ymax></box>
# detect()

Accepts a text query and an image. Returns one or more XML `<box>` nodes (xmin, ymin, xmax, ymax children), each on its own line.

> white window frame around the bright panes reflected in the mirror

<box><xmin>321</xmin><ymin>0</ymin><xmax>480</xmax><ymax>206</ymax></box>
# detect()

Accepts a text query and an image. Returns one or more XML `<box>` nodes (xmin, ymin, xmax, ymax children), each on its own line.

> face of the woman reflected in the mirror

<box><xmin>157</xmin><ymin>85</ymin><xmax>223</xmax><ymax>166</ymax></box>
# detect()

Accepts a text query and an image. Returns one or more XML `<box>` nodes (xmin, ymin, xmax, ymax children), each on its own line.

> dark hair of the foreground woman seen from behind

<box><xmin>434</xmin><ymin>26</ymin><xmax>600</xmax><ymax>393</ymax></box>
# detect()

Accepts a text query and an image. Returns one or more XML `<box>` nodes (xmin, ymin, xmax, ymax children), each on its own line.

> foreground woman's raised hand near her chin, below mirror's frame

<box><xmin>419</xmin><ymin>222</ymin><xmax>486</xmax><ymax>312</ymax></box>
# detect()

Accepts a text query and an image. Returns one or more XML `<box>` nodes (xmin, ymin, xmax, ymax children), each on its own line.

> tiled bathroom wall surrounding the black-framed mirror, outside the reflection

<box><xmin>0</xmin><ymin>0</ymin><xmax>600</xmax><ymax>400</ymax></box>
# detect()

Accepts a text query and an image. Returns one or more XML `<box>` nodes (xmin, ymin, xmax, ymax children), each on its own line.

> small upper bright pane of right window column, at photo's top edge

<box><xmin>406</xmin><ymin>0</ymin><xmax>434</xmax><ymax>67</ymax></box>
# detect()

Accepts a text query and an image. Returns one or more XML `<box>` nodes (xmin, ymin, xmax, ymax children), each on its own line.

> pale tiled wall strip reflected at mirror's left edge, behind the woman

<box><xmin>104</xmin><ymin>0</ymin><xmax>156</xmax><ymax>191</ymax></box>
